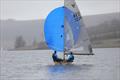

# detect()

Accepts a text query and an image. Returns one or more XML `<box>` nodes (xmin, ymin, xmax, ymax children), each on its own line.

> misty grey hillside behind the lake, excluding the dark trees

<box><xmin>0</xmin><ymin>13</ymin><xmax>120</xmax><ymax>49</ymax></box>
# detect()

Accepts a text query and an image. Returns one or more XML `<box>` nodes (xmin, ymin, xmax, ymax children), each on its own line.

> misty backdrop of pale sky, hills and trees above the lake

<box><xmin>0</xmin><ymin>0</ymin><xmax>120</xmax><ymax>49</ymax></box>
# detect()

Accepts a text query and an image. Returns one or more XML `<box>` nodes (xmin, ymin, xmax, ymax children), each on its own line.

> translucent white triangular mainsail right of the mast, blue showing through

<box><xmin>64</xmin><ymin>0</ymin><xmax>92</xmax><ymax>53</ymax></box>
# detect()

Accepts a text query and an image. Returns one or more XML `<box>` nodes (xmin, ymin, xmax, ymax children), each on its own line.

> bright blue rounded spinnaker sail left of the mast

<box><xmin>44</xmin><ymin>7</ymin><xmax>64</xmax><ymax>51</ymax></box>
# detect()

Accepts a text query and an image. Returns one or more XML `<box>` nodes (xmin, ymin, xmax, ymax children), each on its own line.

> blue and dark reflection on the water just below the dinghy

<box><xmin>48</xmin><ymin>64</ymin><xmax>93</xmax><ymax>74</ymax></box>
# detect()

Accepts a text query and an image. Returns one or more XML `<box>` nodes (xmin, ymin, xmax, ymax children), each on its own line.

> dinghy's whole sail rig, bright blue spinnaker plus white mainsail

<box><xmin>44</xmin><ymin>0</ymin><xmax>93</xmax><ymax>63</ymax></box>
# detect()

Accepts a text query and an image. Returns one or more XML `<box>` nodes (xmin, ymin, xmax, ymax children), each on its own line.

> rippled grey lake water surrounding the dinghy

<box><xmin>0</xmin><ymin>48</ymin><xmax>120</xmax><ymax>80</ymax></box>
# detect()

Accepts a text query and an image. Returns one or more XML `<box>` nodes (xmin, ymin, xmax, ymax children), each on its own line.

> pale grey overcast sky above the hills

<box><xmin>0</xmin><ymin>0</ymin><xmax>120</xmax><ymax>20</ymax></box>
